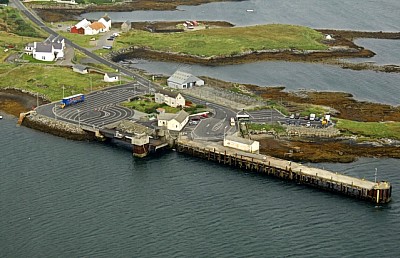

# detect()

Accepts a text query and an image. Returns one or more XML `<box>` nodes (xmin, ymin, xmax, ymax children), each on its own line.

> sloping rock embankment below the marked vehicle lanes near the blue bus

<box><xmin>22</xmin><ymin>112</ymin><xmax>95</xmax><ymax>141</ymax></box>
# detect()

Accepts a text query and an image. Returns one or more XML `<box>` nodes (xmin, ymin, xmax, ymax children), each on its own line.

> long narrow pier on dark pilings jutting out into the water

<box><xmin>176</xmin><ymin>139</ymin><xmax>392</xmax><ymax>204</ymax></box>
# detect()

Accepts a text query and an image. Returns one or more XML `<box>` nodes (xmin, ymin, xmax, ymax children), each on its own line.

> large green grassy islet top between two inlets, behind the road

<box><xmin>115</xmin><ymin>24</ymin><xmax>327</xmax><ymax>57</ymax></box>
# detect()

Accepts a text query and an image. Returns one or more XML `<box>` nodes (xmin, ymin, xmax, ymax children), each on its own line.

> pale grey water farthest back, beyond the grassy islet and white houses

<box><xmin>82</xmin><ymin>0</ymin><xmax>400</xmax><ymax>31</ymax></box>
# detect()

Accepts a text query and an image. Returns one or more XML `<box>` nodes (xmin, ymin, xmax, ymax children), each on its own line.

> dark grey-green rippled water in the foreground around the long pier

<box><xmin>0</xmin><ymin>119</ymin><xmax>400</xmax><ymax>257</ymax></box>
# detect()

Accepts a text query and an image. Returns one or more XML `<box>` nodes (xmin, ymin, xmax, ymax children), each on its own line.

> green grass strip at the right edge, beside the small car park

<box><xmin>336</xmin><ymin>119</ymin><xmax>400</xmax><ymax>140</ymax></box>
